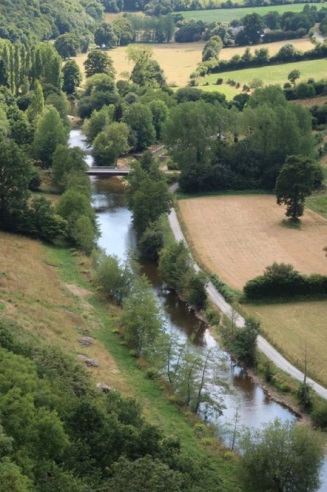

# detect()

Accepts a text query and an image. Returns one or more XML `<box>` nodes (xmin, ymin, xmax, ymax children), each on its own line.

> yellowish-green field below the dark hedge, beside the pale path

<box><xmin>244</xmin><ymin>300</ymin><xmax>327</xmax><ymax>387</ymax></box>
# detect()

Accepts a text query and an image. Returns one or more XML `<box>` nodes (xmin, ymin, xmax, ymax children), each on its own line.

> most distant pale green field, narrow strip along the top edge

<box><xmin>182</xmin><ymin>3</ymin><xmax>320</xmax><ymax>22</ymax></box>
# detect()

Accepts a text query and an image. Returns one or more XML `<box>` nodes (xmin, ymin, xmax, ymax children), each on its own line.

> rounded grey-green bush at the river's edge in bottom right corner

<box><xmin>239</xmin><ymin>420</ymin><xmax>323</xmax><ymax>492</ymax></box>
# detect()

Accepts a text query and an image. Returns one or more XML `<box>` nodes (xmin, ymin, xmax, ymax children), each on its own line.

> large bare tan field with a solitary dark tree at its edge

<box><xmin>179</xmin><ymin>195</ymin><xmax>327</xmax><ymax>289</ymax></box>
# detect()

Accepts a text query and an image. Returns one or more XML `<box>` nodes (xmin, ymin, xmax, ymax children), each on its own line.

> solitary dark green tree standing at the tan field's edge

<box><xmin>276</xmin><ymin>155</ymin><xmax>320</xmax><ymax>221</ymax></box>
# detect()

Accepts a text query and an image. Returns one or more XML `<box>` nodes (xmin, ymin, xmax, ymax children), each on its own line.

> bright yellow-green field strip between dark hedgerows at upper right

<box><xmin>201</xmin><ymin>59</ymin><xmax>327</xmax><ymax>88</ymax></box>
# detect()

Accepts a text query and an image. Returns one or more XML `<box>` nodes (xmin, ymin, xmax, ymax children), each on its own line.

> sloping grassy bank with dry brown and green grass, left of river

<box><xmin>0</xmin><ymin>233</ymin><xmax>241</xmax><ymax>492</ymax></box>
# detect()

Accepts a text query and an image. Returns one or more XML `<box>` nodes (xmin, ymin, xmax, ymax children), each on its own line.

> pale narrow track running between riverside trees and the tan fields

<box><xmin>168</xmin><ymin>209</ymin><xmax>327</xmax><ymax>400</ymax></box>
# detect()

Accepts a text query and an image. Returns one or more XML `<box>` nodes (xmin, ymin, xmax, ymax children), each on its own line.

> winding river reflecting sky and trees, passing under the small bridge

<box><xmin>70</xmin><ymin>130</ymin><xmax>327</xmax><ymax>492</ymax></box>
